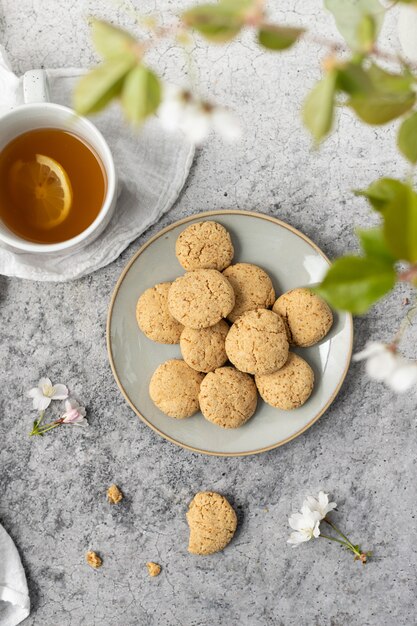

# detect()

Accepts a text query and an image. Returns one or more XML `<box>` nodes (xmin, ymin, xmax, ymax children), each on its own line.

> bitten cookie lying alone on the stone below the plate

<box><xmin>187</xmin><ymin>491</ymin><xmax>237</xmax><ymax>555</ymax></box>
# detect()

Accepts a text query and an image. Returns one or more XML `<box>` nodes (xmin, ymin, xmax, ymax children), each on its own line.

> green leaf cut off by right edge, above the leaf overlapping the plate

<box><xmin>382</xmin><ymin>184</ymin><xmax>417</xmax><ymax>263</ymax></box>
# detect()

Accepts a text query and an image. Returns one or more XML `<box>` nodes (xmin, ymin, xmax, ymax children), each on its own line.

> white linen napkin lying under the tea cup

<box><xmin>0</xmin><ymin>46</ymin><xmax>194</xmax><ymax>282</ymax></box>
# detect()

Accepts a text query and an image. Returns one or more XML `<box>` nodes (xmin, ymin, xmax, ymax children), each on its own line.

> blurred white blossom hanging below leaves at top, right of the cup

<box><xmin>158</xmin><ymin>85</ymin><xmax>241</xmax><ymax>144</ymax></box>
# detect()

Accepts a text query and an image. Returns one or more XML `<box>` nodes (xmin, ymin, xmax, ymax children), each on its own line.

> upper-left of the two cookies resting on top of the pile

<box><xmin>168</xmin><ymin>270</ymin><xmax>235</xmax><ymax>328</ymax></box>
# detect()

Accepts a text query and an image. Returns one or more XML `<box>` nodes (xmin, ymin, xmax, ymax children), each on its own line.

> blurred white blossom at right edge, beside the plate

<box><xmin>353</xmin><ymin>341</ymin><xmax>417</xmax><ymax>393</ymax></box>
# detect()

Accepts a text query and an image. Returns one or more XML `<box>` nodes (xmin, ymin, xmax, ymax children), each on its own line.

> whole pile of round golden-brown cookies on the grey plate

<box><xmin>136</xmin><ymin>221</ymin><xmax>333</xmax><ymax>428</ymax></box>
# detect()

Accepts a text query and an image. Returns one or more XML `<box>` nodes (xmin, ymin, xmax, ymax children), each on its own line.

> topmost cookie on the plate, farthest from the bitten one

<box><xmin>175</xmin><ymin>222</ymin><xmax>234</xmax><ymax>272</ymax></box>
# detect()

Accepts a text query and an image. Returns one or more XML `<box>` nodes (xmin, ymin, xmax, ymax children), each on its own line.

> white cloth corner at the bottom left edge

<box><xmin>0</xmin><ymin>525</ymin><xmax>30</xmax><ymax>626</ymax></box>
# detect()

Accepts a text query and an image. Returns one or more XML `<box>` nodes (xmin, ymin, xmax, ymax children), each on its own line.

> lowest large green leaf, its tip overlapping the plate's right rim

<box><xmin>315</xmin><ymin>256</ymin><xmax>396</xmax><ymax>315</ymax></box>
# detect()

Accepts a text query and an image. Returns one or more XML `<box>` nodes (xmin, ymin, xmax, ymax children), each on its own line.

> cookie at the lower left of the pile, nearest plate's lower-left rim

<box><xmin>149</xmin><ymin>359</ymin><xmax>204</xmax><ymax>419</ymax></box>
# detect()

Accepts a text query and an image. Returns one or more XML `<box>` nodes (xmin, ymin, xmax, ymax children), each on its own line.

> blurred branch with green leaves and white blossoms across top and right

<box><xmin>74</xmin><ymin>0</ymin><xmax>417</xmax><ymax>388</ymax></box>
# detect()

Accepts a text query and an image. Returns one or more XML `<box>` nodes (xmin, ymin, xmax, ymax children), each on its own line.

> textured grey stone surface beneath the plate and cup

<box><xmin>0</xmin><ymin>0</ymin><xmax>417</xmax><ymax>626</ymax></box>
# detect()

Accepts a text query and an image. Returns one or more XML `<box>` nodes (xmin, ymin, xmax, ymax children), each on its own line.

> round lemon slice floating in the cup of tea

<box><xmin>11</xmin><ymin>154</ymin><xmax>72</xmax><ymax>230</ymax></box>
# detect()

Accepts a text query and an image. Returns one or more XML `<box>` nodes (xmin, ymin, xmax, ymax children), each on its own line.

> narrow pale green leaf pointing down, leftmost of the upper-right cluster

<box><xmin>303</xmin><ymin>70</ymin><xmax>337</xmax><ymax>142</ymax></box>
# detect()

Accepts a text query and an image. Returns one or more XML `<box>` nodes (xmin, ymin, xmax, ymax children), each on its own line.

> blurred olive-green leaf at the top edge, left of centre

<box><xmin>182</xmin><ymin>2</ymin><xmax>244</xmax><ymax>43</ymax></box>
